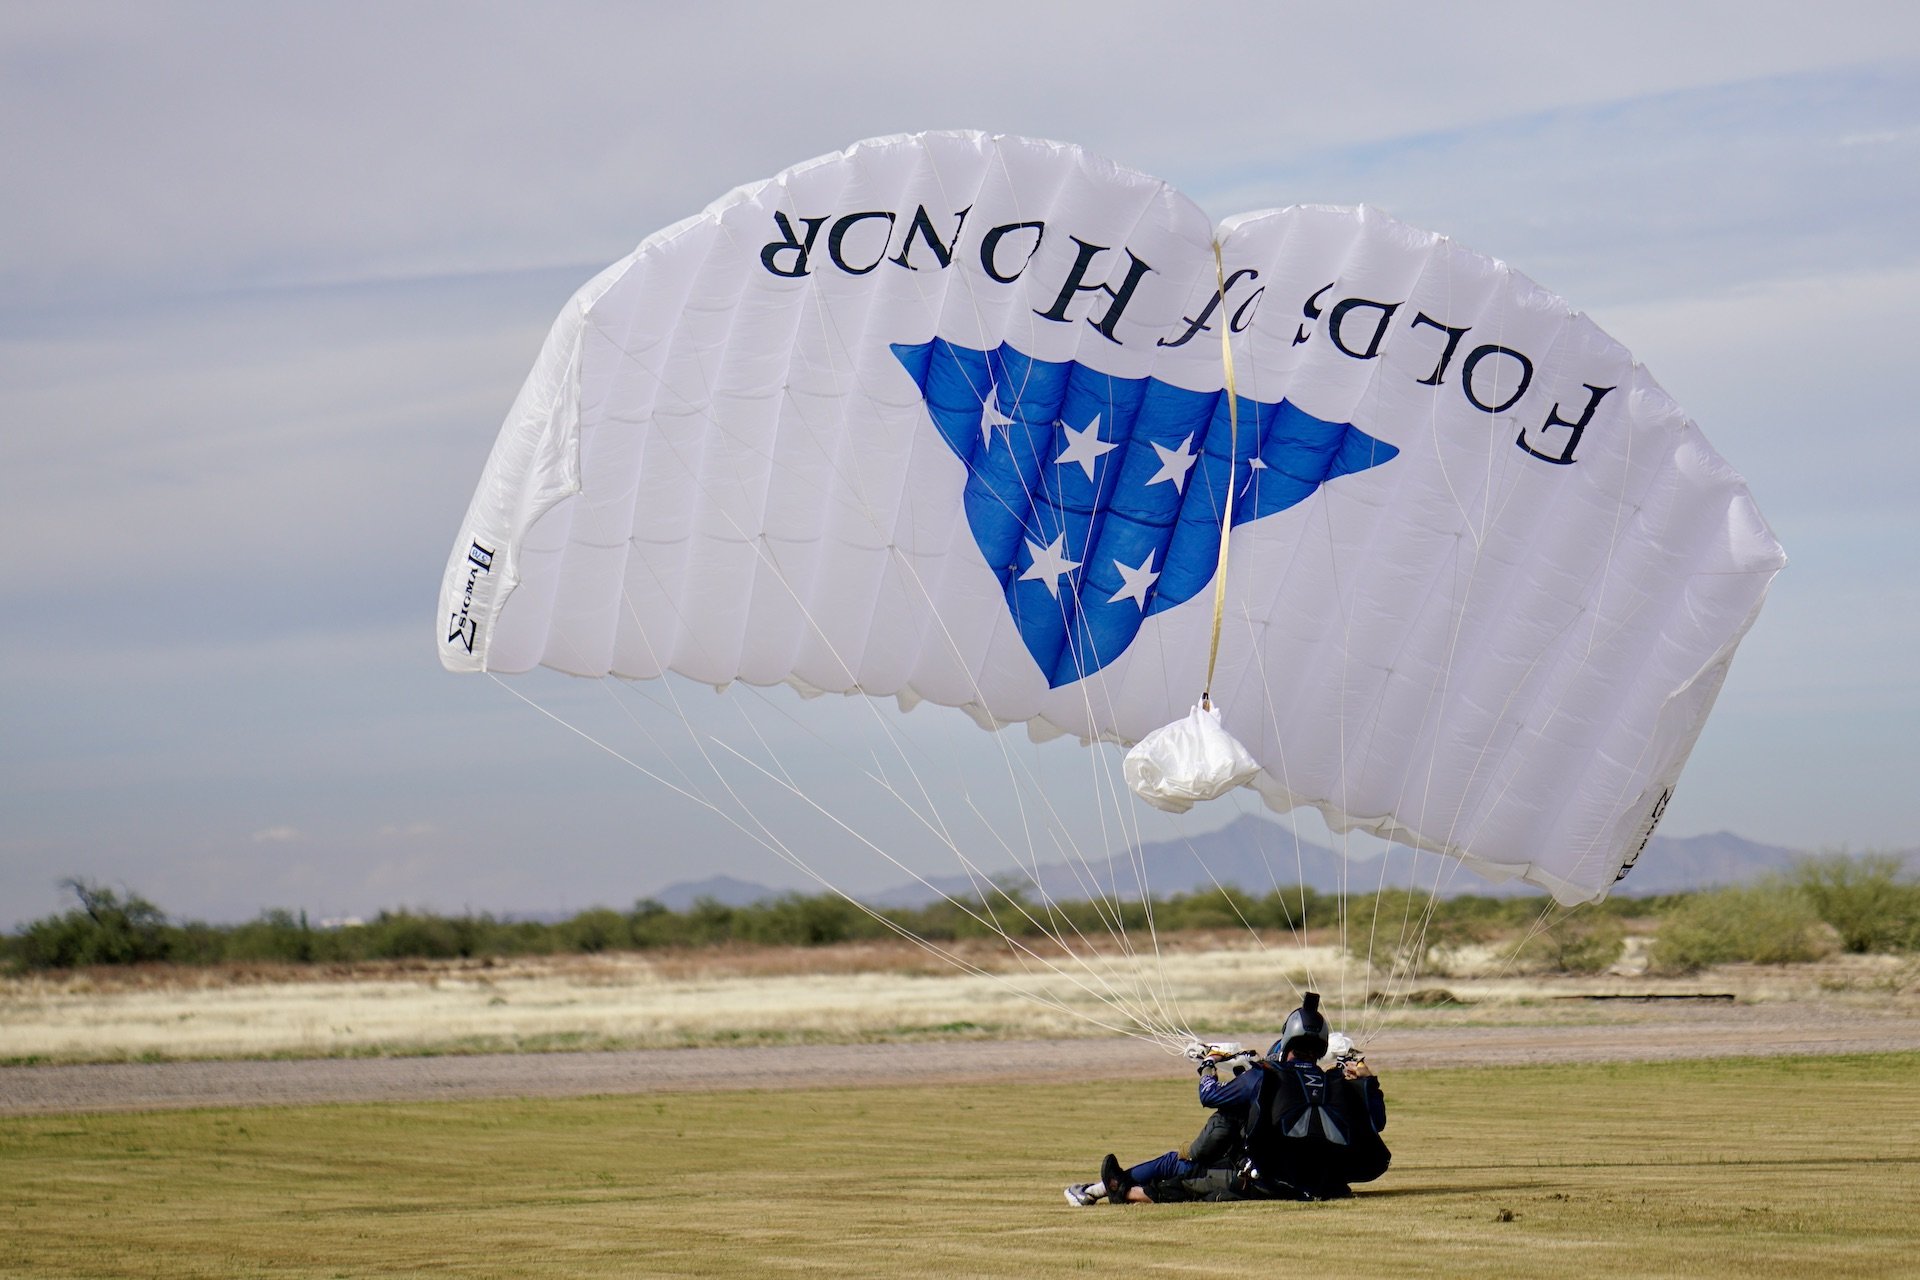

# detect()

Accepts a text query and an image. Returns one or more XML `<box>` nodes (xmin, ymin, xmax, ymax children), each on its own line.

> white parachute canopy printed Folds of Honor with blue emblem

<box><xmin>438</xmin><ymin>132</ymin><xmax>1784</xmax><ymax>902</ymax></box>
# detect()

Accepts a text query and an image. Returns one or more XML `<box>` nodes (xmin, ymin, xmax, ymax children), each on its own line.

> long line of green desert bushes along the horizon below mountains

<box><xmin>0</xmin><ymin>854</ymin><xmax>1920</xmax><ymax>975</ymax></box>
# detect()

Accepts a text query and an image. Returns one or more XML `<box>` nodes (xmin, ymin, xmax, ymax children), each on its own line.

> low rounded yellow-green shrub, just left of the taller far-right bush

<box><xmin>1649</xmin><ymin>881</ymin><xmax>1832</xmax><ymax>973</ymax></box>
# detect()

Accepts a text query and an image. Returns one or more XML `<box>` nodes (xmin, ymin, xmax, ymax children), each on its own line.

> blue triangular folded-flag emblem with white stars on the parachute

<box><xmin>893</xmin><ymin>338</ymin><xmax>1400</xmax><ymax>689</ymax></box>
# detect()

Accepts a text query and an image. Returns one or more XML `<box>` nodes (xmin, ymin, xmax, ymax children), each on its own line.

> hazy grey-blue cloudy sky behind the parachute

<box><xmin>0</xmin><ymin>0</ymin><xmax>1920</xmax><ymax>927</ymax></box>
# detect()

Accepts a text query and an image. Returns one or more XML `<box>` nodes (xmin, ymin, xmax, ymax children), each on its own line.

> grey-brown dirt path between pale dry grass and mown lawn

<box><xmin>0</xmin><ymin>1006</ymin><xmax>1920</xmax><ymax>1115</ymax></box>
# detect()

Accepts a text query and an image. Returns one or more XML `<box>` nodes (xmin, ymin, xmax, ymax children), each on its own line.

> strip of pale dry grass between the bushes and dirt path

<box><xmin>0</xmin><ymin>933</ymin><xmax>1920</xmax><ymax>1063</ymax></box>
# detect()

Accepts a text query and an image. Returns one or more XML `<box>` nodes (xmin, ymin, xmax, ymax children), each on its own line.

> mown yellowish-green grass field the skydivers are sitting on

<box><xmin>0</xmin><ymin>1050</ymin><xmax>1920</xmax><ymax>1280</ymax></box>
